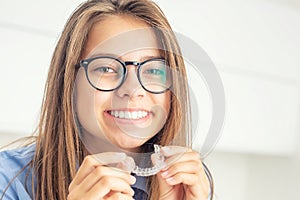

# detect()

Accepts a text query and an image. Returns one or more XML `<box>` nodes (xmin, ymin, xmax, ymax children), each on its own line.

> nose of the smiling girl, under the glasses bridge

<box><xmin>116</xmin><ymin>65</ymin><xmax>146</xmax><ymax>100</ymax></box>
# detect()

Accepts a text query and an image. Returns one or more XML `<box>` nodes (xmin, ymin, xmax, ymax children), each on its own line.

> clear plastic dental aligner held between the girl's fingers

<box><xmin>132</xmin><ymin>144</ymin><xmax>166</xmax><ymax>176</ymax></box>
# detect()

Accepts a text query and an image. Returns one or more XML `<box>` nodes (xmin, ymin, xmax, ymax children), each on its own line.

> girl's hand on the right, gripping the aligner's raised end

<box><xmin>157</xmin><ymin>146</ymin><xmax>209</xmax><ymax>200</ymax></box>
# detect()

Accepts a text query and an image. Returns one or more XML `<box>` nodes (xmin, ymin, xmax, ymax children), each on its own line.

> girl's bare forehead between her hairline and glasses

<box><xmin>83</xmin><ymin>15</ymin><xmax>161</xmax><ymax>59</ymax></box>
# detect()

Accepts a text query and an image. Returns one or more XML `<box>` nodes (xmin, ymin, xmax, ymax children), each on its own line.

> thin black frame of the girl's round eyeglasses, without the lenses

<box><xmin>76</xmin><ymin>56</ymin><xmax>173</xmax><ymax>94</ymax></box>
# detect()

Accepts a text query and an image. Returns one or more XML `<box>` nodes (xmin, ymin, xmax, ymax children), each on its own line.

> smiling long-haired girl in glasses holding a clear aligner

<box><xmin>0</xmin><ymin>0</ymin><xmax>213</xmax><ymax>200</ymax></box>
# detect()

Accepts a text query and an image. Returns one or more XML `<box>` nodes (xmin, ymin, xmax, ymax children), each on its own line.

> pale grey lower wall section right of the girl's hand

<box><xmin>207</xmin><ymin>151</ymin><xmax>300</xmax><ymax>200</ymax></box>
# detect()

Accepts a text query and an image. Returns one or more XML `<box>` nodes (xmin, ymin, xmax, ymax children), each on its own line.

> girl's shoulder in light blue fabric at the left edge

<box><xmin>0</xmin><ymin>145</ymin><xmax>35</xmax><ymax>199</ymax></box>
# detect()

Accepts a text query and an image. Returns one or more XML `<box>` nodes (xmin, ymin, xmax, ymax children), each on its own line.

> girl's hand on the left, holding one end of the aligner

<box><xmin>68</xmin><ymin>153</ymin><xmax>136</xmax><ymax>200</ymax></box>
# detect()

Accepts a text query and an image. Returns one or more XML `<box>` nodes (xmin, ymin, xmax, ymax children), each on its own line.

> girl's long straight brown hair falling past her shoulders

<box><xmin>22</xmin><ymin>0</ymin><xmax>213</xmax><ymax>200</ymax></box>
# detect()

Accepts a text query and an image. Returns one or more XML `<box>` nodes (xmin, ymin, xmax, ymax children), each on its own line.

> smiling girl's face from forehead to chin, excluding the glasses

<box><xmin>76</xmin><ymin>15</ymin><xmax>171</xmax><ymax>151</ymax></box>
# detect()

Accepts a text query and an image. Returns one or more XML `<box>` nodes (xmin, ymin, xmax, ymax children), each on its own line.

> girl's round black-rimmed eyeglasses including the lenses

<box><xmin>76</xmin><ymin>56</ymin><xmax>172</xmax><ymax>94</ymax></box>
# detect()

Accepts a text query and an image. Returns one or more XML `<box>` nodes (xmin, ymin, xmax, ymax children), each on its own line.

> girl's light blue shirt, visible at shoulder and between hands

<box><xmin>0</xmin><ymin>145</ymin><xmax>147</xmax><ymax>200</ymax></box>
